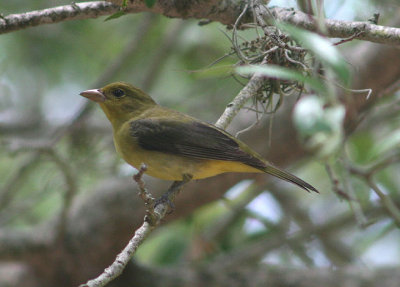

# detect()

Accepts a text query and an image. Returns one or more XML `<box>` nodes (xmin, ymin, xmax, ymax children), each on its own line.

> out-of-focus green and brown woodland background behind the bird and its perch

<box><xmin>0</xmin><ymin>0</ymin><xmax>400</xmax><ymax>286</ymax></box>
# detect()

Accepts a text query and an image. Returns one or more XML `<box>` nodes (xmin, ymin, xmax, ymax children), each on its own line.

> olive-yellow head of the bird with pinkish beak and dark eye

<box><xmin>80</xmin><ymin>82</ymin><xmax>156</xmax><ymax>124</ymax></box>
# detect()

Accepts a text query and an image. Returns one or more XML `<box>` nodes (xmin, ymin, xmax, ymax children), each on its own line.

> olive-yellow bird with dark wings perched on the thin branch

<box><xmin>80</xmin><ymin>82</ymin><xmax>318</xmax><ymax>192</ymax></box>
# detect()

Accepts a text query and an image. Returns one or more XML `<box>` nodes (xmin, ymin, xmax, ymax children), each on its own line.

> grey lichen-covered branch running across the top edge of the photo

<box><xmin>0</xmin><ymin>0</ymin><xmax>400</xmax><ymax>46</ymax></box>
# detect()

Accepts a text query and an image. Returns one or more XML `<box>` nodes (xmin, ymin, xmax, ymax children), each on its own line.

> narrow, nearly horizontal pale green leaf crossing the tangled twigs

<box><xmin>236</xmin><ymin>65</ymin><xmax>326</xmax><ymax>93</ymax></box>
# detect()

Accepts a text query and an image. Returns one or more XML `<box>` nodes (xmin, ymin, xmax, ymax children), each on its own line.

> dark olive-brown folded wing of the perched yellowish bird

<box><xmin>130</xmin><ymin>119</ymin><xmax>265</xmax><ymax>168</ymax></box>
